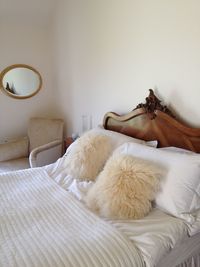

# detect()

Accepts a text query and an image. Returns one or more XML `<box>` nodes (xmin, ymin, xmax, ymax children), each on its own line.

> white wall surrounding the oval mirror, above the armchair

<box><xmin>0</xmin><ymin>20</ymin><xmax>56</xmax><ymax>142</ymax></box>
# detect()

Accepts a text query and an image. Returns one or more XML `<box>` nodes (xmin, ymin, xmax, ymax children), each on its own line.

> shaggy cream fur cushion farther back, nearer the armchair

<box><xmin>65</xmin><ymin>133</ymin><xmax>112</xmax><ymax>180</ymax></box>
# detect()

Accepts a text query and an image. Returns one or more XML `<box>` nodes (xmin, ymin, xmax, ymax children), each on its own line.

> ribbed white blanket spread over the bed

<box><xmin>0</xmin><ymin>168</ymin><xmax>143</xmax><ymax>267</ymax></box>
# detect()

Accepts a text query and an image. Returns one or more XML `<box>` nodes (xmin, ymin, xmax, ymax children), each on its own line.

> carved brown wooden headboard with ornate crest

<box><xmin>103</xmin><ymin>89</ymin><xmax>200</xmax><ymax>152</ymax></box>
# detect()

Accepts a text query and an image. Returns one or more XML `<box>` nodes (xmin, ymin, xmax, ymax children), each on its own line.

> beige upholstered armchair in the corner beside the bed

<box><xmin>0</xmin><ymin>118</ymin><xmax>64</xmax><ymax>173</ymax></box>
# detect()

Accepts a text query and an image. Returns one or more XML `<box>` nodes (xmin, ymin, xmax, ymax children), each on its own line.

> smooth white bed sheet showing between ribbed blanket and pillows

<box><xmin>45</xmin><ymin>159</ymin><xmax>200</xmax><ymax>267</ymax></box>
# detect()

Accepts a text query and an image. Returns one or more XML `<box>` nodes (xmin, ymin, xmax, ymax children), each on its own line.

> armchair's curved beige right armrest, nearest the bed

<box><xmin>29</xmin><ymin>140</ymin><xmax>63</xmax><ymax>168</ymax></box>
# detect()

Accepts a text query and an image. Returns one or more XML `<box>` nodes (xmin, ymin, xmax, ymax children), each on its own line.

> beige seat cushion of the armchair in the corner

<box><xmin>0</xmin><ymin>158</ymin><xmax>30</xmax><ymax>173</ymax></box>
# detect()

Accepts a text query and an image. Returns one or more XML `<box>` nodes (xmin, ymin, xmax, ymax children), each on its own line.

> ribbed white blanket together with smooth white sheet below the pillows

<box><xmin>0</xmin><ymin>156</ymin><xmax>199</xmax><ymax>267</ymax></box>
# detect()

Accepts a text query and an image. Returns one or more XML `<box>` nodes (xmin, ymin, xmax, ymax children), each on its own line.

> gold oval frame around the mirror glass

<box><xmin>0</xmin><ymin>64</ymin><xmax>42</xmax><ymax>99</ymax></box>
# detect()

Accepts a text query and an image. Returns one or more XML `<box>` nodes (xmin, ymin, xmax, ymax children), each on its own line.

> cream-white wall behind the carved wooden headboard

<box><xmin>54</xmin><ymin>0</ymin><xmax>200</xmax><ymax>134</ymax></box>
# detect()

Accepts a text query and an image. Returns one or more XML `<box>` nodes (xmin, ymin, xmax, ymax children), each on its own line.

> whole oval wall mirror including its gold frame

<box><xmin>0</xmin><ymin>64</ymin><xmax>42</xmax><ymax>98</ymax></box>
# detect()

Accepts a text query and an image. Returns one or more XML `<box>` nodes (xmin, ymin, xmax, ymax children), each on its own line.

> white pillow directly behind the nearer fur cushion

<box><xmin>115</xmin><ymin>143</ymin><xmax>200</xmax><ymax>223</ymax></box>
